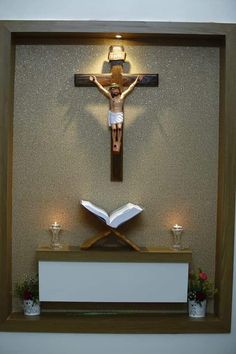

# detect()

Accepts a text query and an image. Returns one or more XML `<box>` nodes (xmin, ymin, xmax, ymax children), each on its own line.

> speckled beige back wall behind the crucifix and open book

<box><xmin>13</xmin><ymin>45</ymin><xmax>219</xmax><ymax>308</ymax></box>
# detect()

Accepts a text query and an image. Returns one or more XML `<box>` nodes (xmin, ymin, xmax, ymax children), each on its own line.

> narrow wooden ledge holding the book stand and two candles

<box><xmin>36</xmin><ymin>246</ymin><xmax>192</xmax><ymax>263</ymax></box>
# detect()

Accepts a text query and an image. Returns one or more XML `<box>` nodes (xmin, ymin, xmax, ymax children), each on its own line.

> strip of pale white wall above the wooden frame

<box><xmin>0</xmin><ymin>0</ymin><xmax>236</xmax><ymax>22</ymax></box>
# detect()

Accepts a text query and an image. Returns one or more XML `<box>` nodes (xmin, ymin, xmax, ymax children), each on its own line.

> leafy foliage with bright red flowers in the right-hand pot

<box><xmin>188</xmin><ymin>268</ymin><xmax>217</xmax><ymax>304</ymax></box>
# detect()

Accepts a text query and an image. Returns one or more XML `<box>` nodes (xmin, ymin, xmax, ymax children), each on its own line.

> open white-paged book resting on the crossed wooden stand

<box><xmin>81</xmin><ymin>200</ymin><xmax>143</xmax><ymax>229</ymax></box>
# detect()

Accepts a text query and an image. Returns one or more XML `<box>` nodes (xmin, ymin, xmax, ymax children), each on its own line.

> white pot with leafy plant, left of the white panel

<box><xmin>15</xmin><ymin>274</ymin><xmax>40</xmax><ymax>316</ymax></box>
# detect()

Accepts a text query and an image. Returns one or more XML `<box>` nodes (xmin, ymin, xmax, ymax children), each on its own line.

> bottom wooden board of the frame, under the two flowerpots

<box><xmin>0</xmin><ymin>312</ymin><xmax>227</xmax><ymax>333</ymax></box>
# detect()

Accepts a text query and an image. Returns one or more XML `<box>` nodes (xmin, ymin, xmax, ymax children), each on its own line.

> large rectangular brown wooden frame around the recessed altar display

<box><xmin>0</xmin><ymin>21</ymin><xmax>236</xmax><ymax>333</ymax></box>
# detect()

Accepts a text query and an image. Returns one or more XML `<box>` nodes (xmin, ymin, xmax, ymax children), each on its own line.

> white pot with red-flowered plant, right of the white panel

<box><xmin>188</xmin><ymin>268</ymin><xmax>217</xmax><ymax>317</ymax></box>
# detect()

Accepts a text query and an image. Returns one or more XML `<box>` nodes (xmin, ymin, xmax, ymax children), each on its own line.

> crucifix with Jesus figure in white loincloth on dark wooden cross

<box><xmin>75</xmin><ymin>46</ymin><xmax>158</xmax><ymax>182</ymax></box>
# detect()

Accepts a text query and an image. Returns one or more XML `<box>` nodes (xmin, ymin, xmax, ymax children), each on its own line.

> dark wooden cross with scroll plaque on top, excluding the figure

<box><xmin>75</xmin><ymin>46</ymin><xmax>158</xmax><ymax>182</ymax></box>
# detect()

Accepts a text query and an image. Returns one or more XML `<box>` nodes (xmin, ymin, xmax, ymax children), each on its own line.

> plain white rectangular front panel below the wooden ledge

<box><xmin>39</xmin><ymin>261</ymin><xmax>188</xmax><ymax>302</ymax></box>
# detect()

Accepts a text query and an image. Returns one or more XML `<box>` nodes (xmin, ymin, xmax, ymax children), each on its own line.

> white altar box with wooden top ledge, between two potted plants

<box><xmin>37</xmin><ymin>247</ymin><xmax>191</xmax><ymax>303</ymax></box>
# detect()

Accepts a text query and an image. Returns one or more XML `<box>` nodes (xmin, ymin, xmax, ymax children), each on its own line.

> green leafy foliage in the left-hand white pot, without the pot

<box><xmin>15</xmin><ymin>274</ymin><xmax>39</xmax><ymax>303</ymax></box>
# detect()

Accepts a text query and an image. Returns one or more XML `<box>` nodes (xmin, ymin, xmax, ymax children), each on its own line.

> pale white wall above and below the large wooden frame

<box><xmin>0</xmin><ymin>0</ymin><xmax>236</xmax><ymax>354</ymax></box>
